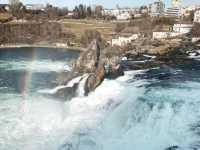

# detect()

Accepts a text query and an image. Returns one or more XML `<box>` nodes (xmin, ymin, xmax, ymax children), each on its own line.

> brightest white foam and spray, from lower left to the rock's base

<box><xmin>0</xmin><ymin>70</ymin><xmax>145</xmax><ymax>150</ymax></box>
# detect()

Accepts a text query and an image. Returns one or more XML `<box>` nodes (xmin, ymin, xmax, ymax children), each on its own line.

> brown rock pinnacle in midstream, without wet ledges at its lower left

<box><xmin>73</xmin><ymin>40</ymin><xmax>123</xmax><ymax>95</ymax></box>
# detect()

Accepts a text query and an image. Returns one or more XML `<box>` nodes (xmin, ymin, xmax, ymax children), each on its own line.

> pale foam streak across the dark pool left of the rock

<box><xmin>0</xmin><ymin>60</ymin><xmax>71</xmax><ymax>72</ymax></box>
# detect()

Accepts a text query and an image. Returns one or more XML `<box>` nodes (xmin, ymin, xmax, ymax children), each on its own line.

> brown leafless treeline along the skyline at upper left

<box><xmin>0</xmin><ymin>0</ymin><xmax>103</xmax><ymax>20</ymax></box>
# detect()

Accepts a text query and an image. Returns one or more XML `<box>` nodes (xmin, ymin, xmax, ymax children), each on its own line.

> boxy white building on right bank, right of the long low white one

<box><xmin>173</xmin><ymin>23</ymin><xmax>193</xmax><ymax>34</ymax></box>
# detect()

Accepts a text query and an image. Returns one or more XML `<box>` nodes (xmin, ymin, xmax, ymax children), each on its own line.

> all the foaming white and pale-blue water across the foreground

<box><xmin>0</xmin><ymin>71</ymin><xmax>200</xmax><ymax>150</ymax></box>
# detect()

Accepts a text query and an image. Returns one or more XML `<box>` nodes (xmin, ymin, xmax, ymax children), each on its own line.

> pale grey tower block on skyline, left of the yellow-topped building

<box><xmin>149</xmin><ymin>0</ymin><xmax>165</xmax><ymax>16</ymax></box>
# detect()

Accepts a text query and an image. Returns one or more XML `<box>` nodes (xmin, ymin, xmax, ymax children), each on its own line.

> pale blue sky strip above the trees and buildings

<box><xmin>0</xmin><ymin>0</ymin><xmax>200</xmax><ymax>9</ymax></box>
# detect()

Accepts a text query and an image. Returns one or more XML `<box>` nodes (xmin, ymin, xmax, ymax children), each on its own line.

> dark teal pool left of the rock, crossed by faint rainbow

<box><xmin>0</xmin><ymin>48</ymin><xmax>80</xmax><ymax>92</ymax></box>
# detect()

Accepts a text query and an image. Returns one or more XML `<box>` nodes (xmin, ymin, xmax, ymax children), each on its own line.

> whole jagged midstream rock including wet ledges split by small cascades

<box><xmin>57</xmin><ymin>40</ymin><xmax>124</xmax><ymax>97</ymax></box>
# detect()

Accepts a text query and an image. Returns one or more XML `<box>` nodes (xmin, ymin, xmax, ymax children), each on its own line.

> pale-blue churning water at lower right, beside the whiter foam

<box><xmin>70</xmin><ymin>82</ymin><xmax>200</xmax><ymax>150</ymax></box>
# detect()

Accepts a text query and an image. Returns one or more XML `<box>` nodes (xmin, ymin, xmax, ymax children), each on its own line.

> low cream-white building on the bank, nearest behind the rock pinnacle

<box><xmin>111</xmin><ymin>34</ymin><xmax>140</xmax><ymax>46</ymax></box>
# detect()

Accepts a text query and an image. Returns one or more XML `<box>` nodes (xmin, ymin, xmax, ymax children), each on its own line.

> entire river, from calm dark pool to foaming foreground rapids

<box><xmin>0</xmin><ymin>49</ymin><xmax>200</xmax><ymax>150</ymax></box>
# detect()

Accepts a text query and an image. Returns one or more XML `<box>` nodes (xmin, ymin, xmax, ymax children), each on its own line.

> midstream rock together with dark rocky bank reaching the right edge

<box><xmin>52</xmin><ymin>39</ymin><xmax>200</xmax><ymax>99</ymax></box>
